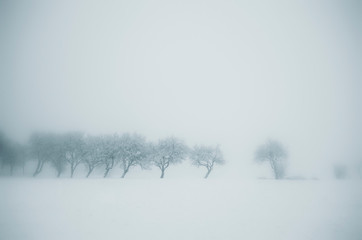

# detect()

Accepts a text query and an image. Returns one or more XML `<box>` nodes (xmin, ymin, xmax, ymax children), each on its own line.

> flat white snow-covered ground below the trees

<box><xmin>0</xmin><ymin>179</ymin><xmax>362</xmax><ymax>240</ymax></box>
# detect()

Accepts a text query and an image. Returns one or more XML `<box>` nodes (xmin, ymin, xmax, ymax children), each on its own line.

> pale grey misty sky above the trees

<box><xmin>0</xmin><ymin>0</ymin><xmax>362</xmax><ymax>176</ymax></box>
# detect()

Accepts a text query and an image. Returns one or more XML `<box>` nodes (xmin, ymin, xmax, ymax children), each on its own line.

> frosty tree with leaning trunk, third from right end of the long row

<box><xmin>119</xmin><ymin>133</ymin><xmax>149</xmax><ymax>178</ymax></box>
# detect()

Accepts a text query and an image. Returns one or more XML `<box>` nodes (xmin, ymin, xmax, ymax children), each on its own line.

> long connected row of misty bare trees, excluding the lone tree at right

<box><xmin>0</xmin><ymin>132</ymin><xmax>225</xmax><ymax>178</ymax></box>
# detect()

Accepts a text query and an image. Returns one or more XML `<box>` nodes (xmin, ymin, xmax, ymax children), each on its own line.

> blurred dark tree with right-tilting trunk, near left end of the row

<box><xmin>29</xmin><ymin>132</ymin><xmax>52</xmax><ymax>177</ymax></box>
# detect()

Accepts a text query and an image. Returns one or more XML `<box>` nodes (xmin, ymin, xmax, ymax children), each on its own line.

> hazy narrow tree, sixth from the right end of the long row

<box><xmin>64</xmin><ymin>132</ymin><xmax>86</xmax><ymax>178</ymax></box>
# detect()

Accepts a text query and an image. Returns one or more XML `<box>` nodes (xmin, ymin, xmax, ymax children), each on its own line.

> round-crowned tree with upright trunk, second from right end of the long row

<box><xmin>152</xmin><ymin>137</ymin><xmax>188</xmax><ymax>178</ymax></box>
